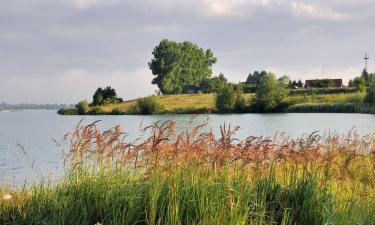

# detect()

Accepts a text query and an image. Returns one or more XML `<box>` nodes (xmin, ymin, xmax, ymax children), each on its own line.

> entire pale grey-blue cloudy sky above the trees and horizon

<box><xmin>0</xmin><ymin>0</ymin><xmax>375</xmax><ymax>103</ymax></box>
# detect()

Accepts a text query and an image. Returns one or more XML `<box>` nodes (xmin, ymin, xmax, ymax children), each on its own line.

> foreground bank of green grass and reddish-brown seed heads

<box><xmin>0</xmin><ymin>121</ymin><xmax>375</xmax><ymax>225</ymax></box>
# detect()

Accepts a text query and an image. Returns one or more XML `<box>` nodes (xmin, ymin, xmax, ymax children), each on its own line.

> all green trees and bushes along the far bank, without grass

<box><xmin>71</xmin><ymin>39</ymin><xmax>375</xmax><ymax>114</ymax></box>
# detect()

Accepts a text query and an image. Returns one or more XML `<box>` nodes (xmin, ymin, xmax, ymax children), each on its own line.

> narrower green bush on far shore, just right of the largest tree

<box><xmin>216</xmin><ymin>84</ymin><xmax>236</xmax><ymax>112</ymax></box>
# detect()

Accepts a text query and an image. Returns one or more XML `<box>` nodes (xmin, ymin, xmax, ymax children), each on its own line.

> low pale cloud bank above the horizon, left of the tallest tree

<box><xmin>0</xmin><ymin>68</ymin><xmax>157</xmax><ymax>103</ymax></box>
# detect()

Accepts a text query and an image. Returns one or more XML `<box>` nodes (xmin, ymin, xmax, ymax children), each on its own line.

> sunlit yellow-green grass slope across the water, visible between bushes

<box><xmin>96</xmin><ymin>93</ymin><xmax>364</xmax><ymax>113</ymax></box>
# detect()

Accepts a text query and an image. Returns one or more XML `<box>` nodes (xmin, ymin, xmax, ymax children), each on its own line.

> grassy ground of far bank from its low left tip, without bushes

<box><xmin>59</xmin><ymin>92</ymin><xmax>365</xmax><ymax>115</ymax></box>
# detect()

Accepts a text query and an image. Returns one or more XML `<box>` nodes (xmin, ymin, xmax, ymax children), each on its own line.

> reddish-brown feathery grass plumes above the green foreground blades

<box><xmin>56</xmin><ymin>120</ymin><xmax>375</xmax><ymax>186</ymax></box>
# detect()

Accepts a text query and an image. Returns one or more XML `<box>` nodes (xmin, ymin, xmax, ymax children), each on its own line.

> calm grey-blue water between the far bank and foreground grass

<box><xmin>0</xmin><ymin>110</ymin><xmax>375</xmax><ymax>185</ymax></box>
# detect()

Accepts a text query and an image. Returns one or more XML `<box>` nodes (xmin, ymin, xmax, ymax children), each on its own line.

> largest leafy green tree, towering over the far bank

<box><xmin>149</xmin><ymin>39</ymin><xmax>217</xmax><ymax>94</ymax></box>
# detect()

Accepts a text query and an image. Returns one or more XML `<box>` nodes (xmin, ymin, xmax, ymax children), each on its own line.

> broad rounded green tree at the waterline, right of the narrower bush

<box><xmin>253</xmin><ymin>73</ymin><xmax>287</xmax><ymax>112</ymax></box>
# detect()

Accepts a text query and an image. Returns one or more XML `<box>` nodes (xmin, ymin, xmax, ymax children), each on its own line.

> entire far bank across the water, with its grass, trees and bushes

<box><xmin>58</xmin><ymin>39</ymin><xmax>375</xmax><ymax>115</ymax></box>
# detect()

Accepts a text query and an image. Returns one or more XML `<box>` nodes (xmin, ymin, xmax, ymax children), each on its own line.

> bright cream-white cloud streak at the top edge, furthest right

<box><xmin>290</xmin><ymin>1</ymin><xmax>351</xmax><ymax>21</ymax></box>
